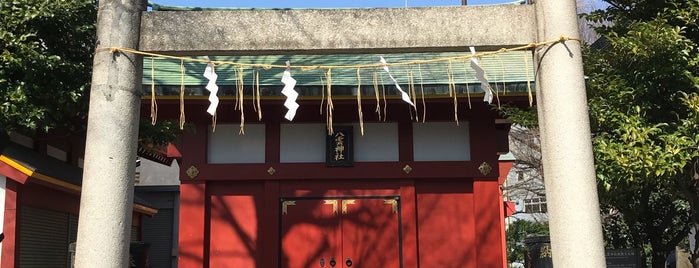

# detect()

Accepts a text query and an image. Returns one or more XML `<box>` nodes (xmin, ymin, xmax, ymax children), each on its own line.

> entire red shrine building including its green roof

<box><xmin>142</xmin><ymin>52</ymin><xmax>533</xmax><ymax>268</ymax></box>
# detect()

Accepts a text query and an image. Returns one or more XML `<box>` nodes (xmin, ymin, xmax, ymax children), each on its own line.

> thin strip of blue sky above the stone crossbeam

<box><xmin>151</xmin><ymin>0</ymin><xmax>515</xmax><ymax>8</ymax></box>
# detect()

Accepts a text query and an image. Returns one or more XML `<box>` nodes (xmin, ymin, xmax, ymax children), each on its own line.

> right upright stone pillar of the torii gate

<box><xmin>535</xmin><ymin>0</ymin><xmax>606</xmax><ymax>267</ymax></box>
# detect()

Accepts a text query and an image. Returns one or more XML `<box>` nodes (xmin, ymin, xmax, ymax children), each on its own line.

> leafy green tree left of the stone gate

<box><xmin>0</xmin><ymin>0</ymin><xmax>97</xmax><ymax>134</ymax></box>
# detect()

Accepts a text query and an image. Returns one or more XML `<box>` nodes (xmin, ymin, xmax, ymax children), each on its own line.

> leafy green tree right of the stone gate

<box><xmin>585</xmin><ymin>0</ymin><xmax>699</xmax><ymax>267</ymax></box>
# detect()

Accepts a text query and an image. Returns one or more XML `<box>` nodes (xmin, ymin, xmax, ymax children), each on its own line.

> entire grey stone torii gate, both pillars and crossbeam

<box><xmin>76</xmin><ymin>0</ymin><xmax>605</xmax><ymax>267</ymax></box>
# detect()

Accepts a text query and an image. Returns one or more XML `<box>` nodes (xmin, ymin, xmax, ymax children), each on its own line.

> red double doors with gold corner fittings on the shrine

<box><xmin>280</xmin><ymin>196</ymin><xmax>402</xmax><ymax>268</ymax></box>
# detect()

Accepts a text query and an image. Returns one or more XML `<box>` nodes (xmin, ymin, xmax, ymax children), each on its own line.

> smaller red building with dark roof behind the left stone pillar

<box><xmin>0</xmin><ymin>133</ymin><xmax>158</xmax><ymax>267</ymax></box>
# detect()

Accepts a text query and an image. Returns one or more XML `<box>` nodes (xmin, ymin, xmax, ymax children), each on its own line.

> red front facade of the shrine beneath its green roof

<box><xmin>150</xmin><ymin>93</ymin><xmax>524</xmax><ymax>268</ymax></box>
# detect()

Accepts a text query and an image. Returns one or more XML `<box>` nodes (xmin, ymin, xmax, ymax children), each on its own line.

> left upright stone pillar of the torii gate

<box><xmin>75</xmin><ymin>0</ymin><xmax>146</xmax><ymax>268</ymax></box>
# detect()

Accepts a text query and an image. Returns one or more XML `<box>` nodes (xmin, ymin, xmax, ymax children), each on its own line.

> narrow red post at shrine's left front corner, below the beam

<box><xmin>178</xmin><ymin>182</ymin><xmax>207</xmax><ymax>268</ymax></box>
